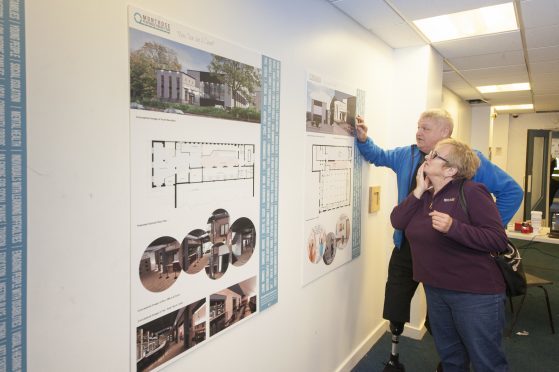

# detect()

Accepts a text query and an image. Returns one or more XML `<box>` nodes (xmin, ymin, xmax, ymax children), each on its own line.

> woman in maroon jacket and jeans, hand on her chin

<box><xmin>391</xmin><ymin>139</ymin><xmax>508</xmax><ymax>372</ymax></box>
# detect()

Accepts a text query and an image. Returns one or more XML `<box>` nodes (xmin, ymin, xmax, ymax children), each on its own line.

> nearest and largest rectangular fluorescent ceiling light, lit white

<box><xmin>413</xmin><ymin>2</ymin><xmax>518</xmax><ymax>43</ymax></box>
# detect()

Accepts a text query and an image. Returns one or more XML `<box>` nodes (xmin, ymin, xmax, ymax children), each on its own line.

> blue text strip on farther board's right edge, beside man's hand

<box><xmin>351</xmin><ymin>89</ymin><xmax>365</xmax><ymax>259</ymax></box>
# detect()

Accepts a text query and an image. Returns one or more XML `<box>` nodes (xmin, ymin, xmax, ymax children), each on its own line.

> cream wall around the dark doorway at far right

<box><xmin>504</xmin><ymin>113</ymin><xmax>559</xmax><ymax>221</ymax></box>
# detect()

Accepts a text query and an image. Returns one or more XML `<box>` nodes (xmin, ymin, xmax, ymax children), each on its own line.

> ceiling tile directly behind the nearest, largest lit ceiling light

<box><xmin>432</xmin><ymin>31</ymin><xmax>522</xmax><ymax>58</ymax></box>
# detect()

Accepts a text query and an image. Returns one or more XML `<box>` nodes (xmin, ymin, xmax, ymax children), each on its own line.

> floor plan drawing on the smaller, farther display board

<box><xmin>312</xmin><ymin>144</ymin><xmax>353</xmax><ymax>213</ymax></box>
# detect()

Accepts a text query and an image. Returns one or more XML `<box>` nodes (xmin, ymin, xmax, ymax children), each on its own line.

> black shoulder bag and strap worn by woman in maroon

<box><xmin>459</xmin><ymin>180</ymin><xmax>526</xmax><ymax>297</ymax></box>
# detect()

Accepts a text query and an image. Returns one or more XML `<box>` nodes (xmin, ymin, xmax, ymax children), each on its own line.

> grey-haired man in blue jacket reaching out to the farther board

<box><xmin>355</xmin><ymin>109</ymin><xmax>524</xmax><ymax>370</ymax></box>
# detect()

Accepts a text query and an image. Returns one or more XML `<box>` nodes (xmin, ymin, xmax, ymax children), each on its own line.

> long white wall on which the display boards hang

<box><xmin>26</xmin><ymin>0</ymin><xmax>416</xmax><ymax>372</ymax></box>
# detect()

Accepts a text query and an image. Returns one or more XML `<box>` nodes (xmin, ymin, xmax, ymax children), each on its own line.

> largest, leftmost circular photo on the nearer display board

<box><xmin>139</xmin><ymin>236</ymin><xmax>182</xmax><ymax>292</ymax></box>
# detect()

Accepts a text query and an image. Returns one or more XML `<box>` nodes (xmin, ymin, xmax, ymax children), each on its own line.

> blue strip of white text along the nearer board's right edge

<box><xmin>259</xmin><ymin>56</ymin><xmax>281</xmax><ymax>311</ymax></box>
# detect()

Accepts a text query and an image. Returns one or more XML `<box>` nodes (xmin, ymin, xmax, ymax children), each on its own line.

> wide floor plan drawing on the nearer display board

<box><xmin>152</xmin><ymin>140</ymin><xmax>255</xmax><ymax>208</ymax></box>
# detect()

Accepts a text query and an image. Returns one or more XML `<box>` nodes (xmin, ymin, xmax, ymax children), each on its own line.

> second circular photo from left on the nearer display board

<box><xmin>181</xmin><ymin>229</ymin><xmax>212</xmax><ymax>274</ymax></box>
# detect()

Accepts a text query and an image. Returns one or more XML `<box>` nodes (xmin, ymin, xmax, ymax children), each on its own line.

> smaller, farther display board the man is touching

<box><xmin>301</xmin><ymin>74</ymin><xmax>365</xmax><ymax>285</ymax></box>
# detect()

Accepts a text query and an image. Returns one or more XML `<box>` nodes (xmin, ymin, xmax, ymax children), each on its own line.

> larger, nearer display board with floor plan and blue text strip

<box><xmin>128</xmin><ymin>7</ymin><xmax>280</xmax><ymax>371</ymax></box>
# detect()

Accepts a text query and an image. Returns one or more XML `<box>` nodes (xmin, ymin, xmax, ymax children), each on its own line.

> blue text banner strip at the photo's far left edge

<box><xmin>0</xmin><ymin>0</ymin><xmax>27</xmax><ymax>371</ymax></box>
